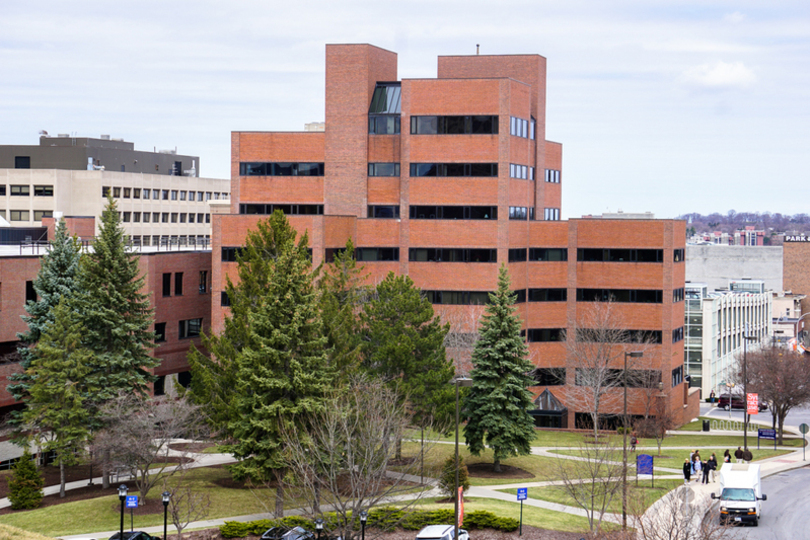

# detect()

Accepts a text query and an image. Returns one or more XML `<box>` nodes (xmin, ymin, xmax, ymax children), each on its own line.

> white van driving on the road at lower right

<box><xmin>712</xmin><ymin>463</ymin><xmax>768</xmax><ymax>527</ymax></box>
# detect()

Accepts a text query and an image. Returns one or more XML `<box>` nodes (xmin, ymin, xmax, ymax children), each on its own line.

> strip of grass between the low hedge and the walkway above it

<box><xmin>410</xmin><ymin>497</ymin><xmax>608</xmax><ymax>536</ymax></box>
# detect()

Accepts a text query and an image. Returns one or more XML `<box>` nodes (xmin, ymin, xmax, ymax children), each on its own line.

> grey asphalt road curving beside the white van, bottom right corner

<box><xmin>732</xmin><ymin>467</ymin><xmax>810</xmax><ymax>540</ymax></box>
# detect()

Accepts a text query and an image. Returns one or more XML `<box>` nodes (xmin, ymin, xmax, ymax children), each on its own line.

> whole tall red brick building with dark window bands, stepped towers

<box><xmin>212</xmin><ymin>45</ymin><xmax>698</xmax><ymax>427</ymax></box>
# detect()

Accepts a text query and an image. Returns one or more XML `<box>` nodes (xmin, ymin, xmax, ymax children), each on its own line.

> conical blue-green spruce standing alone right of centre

<box><xmin>464</xmin><ymin>265</ymin><xmax>534</xmax><ymax>472</ymax></box>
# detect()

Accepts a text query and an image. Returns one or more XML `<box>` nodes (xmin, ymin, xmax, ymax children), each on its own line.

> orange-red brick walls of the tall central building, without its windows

<box><xmin>212</xmin><ymin>45</ymin><xmax>698</xmax><ymax>427</ymax></box>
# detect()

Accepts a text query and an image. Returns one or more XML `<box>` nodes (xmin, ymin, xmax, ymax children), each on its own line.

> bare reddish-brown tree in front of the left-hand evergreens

<box><xmin>94</xmin><ymin>393</ymin><xmax>205</xmax><ymax>500</ymax></box>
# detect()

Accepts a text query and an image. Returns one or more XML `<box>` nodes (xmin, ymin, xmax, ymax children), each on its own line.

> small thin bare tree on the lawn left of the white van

<box><xmin>554</xmin><ymin>439</ymin><xmax>622</xmax><ymax>535</ymax></box>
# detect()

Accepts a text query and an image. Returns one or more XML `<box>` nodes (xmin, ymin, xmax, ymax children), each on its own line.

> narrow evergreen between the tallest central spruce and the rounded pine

<box><xmin>318</xmin><ymin>239</ymin><xmax>369</xmax><ymax>380</ymax></box>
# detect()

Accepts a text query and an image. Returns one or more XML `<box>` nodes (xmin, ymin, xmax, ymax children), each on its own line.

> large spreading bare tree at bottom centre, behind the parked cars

<box><xmin>283</xmin><ymin>378</ymin><xmax>430</xmax><ymax>540</ymax></box>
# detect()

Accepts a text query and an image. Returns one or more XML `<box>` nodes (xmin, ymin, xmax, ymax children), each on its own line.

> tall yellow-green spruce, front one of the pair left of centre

<box><xmin>228</xmin><ymin>226</ymin><xmax>333</xmax><ymax>517</ymax></box>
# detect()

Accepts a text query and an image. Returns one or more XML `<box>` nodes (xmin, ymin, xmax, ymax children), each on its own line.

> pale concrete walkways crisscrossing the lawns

<box><xmin>17</xmin><ymin>426</ymin><xmax>808</xmax><ymax>540</ymax></box>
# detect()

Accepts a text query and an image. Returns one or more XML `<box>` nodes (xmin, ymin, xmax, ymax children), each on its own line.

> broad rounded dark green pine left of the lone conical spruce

<box><xmin>361</xmin><ymin>272</ymin><xmax>455</xmax><ymax>436</ymax></box>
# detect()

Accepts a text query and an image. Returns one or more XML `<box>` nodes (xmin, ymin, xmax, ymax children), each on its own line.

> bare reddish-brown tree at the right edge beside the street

<box><xmin>736</xmin><ymin>347</ymin><xmax>810</xmax><ymax>444</ymax></box>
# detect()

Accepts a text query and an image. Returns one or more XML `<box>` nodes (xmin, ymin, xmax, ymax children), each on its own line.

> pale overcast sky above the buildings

<box><xmin>0</xmin><ymin>0</ymin><xmax>810</xmax><ymax>218</ymax></box>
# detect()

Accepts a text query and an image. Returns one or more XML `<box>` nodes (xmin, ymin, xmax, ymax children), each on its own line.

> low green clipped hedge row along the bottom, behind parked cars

<box><xmin>219</xmin><ymin>507</ymin><xmax>520</xmax><ymax>538</ymax></box>
